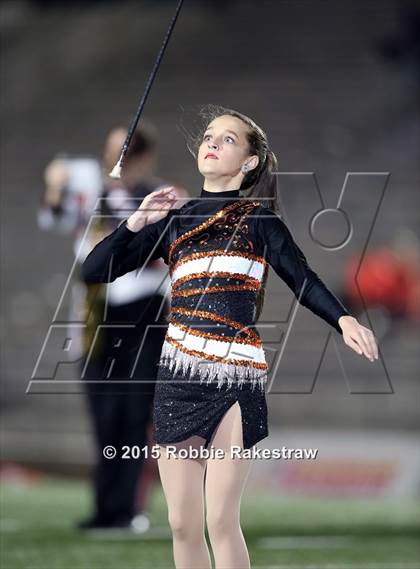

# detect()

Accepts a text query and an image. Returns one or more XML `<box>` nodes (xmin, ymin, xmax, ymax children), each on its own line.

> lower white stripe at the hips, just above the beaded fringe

<box><xmin>167</xmin><ymin>323</ymin><xmax>266</xmax><ymax>367</ymax></box>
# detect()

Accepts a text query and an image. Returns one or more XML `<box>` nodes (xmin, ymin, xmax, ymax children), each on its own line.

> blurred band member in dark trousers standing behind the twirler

<box><xmin>38</xmin><ymin>123</ymin><xmax>187</xmax><ymax>532</ymax></box>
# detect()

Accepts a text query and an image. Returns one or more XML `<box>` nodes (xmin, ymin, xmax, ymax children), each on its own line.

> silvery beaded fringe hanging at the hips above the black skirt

<box><xmin>159</xmin><ymin>341</ymin><xmax>267</xmax><ymax>390</ymax></box>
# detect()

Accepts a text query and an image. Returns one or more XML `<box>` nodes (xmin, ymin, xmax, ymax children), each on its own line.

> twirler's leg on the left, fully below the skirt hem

<box><xmin>158</xmin><ymin>440</ymin><xmax>211</xmax><ymax>569</ymax></box>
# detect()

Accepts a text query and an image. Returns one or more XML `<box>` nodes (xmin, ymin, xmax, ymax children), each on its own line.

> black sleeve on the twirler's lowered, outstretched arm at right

<box><xmin>258</xmin><ymin>207</ymin><xmax>351</xmax><ymax>334</ymax></box>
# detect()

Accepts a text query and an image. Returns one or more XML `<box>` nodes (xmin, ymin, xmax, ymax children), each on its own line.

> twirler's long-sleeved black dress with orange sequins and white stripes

<box><xmin>82</xmin><ymin>189</ymin><xmax>349</xmax><ymax>449</ymax></box>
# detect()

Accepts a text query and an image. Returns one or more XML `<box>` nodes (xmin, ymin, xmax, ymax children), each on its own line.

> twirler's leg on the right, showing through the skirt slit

<box><xmin>205</xmin><ymin>402</ymin><xmax>252</xmax><ymax>569</ymax></box>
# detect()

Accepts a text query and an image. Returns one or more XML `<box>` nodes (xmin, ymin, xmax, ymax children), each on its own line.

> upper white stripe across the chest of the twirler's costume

<box><xmin>172</xmin><ymin>255</ymin><xmax>264</xmax><ymax>282</ymax></box>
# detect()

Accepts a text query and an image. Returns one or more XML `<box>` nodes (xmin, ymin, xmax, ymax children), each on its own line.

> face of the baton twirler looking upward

<box><xmin>197</xmin><ymin>115</ymin><xmax>253</xmax><ymax>179</ymax></box>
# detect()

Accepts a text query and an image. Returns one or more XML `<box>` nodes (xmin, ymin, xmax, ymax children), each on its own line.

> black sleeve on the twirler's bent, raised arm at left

<box><xmin>81</xmin><ymin>210</ymin><xmax>174</xmax><ymax>283</ymax></box>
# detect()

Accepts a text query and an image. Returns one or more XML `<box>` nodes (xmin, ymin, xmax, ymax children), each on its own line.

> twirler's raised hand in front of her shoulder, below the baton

<box><xmin>126</xmin><ymin>186</ymin><xmax>178</xmax><ymax>232</ymax></box>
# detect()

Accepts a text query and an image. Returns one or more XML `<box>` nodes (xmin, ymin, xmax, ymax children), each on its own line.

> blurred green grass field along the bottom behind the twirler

<box><xmin>0</xmin><ymin>479</ymin><xmax>420</xmax><ymax>569</ymax></box>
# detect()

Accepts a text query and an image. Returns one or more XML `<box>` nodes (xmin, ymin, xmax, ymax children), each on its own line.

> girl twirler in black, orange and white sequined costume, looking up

<box><xmin>83</xmin><ymin>108</ymin><xmax>378</xmax><ymax>569</ymax></box>
